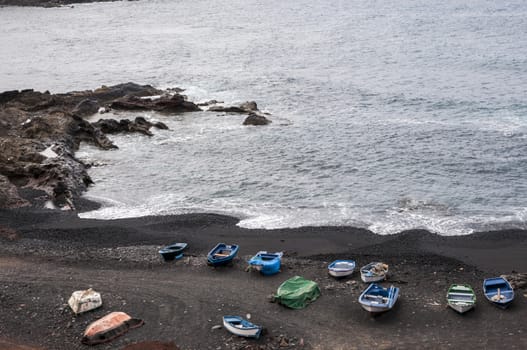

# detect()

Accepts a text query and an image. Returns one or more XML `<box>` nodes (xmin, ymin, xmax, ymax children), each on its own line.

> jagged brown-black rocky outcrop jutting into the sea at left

<box><xmin>0</xmin><ymin>83</ymin><xmax>270</xmax><ymax>209</ymax></box>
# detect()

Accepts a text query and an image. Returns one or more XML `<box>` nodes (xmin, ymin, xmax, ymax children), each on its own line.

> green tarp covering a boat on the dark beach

<box><xmin>275</xmin><ymin>276</ymin><xmax>320</xmax><ymax>309</ymax></box>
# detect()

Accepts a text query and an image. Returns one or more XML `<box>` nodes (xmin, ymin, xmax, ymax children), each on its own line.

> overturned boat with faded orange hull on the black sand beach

<box><xmin>82</xmin><ymin>312</ymin><xmax>144</xmax><ymax>345</ymax></box>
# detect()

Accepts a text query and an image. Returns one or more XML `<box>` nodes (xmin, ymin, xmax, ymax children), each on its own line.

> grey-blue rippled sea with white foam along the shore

<box><xmin>0</xmin><ymin>0</ymin><xmax>527</xmax><ymax>235</ymax></box>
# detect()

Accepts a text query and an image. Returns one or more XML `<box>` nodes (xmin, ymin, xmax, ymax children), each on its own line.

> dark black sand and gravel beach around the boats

<box><xmin>0</xmin><ymin>209</ymin><xmax>527</xmax><ymax>350</ymax></box>
